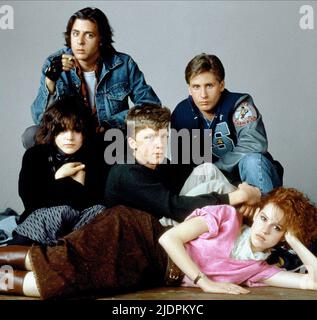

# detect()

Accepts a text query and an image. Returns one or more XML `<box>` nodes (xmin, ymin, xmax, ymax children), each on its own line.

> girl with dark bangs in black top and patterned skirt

<box><xmin>9</xmin><ymin>96</ymin><xmax>104</xmax><ymax>244</ymax></box>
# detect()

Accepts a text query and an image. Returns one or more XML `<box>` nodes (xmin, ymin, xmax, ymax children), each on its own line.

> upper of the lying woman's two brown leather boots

<box><xmin>0</xmin><ymin>245</ymin><xmax>30</xmax><ymax>270</ymax></box>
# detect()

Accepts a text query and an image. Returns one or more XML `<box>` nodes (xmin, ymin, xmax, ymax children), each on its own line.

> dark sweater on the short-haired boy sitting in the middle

<box><xmin>105</xmin><ymin>164</ymin><xmax>229</xmax><ymax>221</ymax></box>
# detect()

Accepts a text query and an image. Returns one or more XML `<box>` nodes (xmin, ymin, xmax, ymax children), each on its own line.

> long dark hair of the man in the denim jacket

<box><xmin>64</xmin><ymin>7</ymin><xmax>116</xmax><ymax>58</ymax></box>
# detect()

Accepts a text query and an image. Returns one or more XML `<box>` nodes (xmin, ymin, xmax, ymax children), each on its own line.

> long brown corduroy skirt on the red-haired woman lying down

<box><xmin>30</xmin><ymin>206</ymin><xmax>167</xmax><ymax>299</ymax></box>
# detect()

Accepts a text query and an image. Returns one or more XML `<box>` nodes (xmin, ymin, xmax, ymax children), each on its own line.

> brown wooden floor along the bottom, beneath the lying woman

<box><xmin>0</xmin><ymin>287</ymin><xmax>317</xmax><ymax>301</ymax></box>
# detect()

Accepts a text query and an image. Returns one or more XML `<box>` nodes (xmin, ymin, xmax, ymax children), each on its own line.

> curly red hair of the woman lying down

<box><xmin>257</xmin><ymin>187</ymin><xmax>317</xmax><ymax>246</ymax></box>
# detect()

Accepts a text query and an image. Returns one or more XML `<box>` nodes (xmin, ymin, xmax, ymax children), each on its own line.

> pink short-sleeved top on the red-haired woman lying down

<box><xmin>182</xmin><ymin>205</ymin><xmax>281</xmax><ymax>287</ymax></box>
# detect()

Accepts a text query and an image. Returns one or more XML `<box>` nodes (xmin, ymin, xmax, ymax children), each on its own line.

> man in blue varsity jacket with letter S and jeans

<box><xmin>171</xmin><ymin>53</ymin><xmax>283</xmax><ymax>193</ymax></box>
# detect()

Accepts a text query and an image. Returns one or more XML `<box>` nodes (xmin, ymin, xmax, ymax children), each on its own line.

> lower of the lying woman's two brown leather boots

<box><xmin>0</xmin><ymin>267</ymin><xmax>28</xmax><ymax>295</ymax></box>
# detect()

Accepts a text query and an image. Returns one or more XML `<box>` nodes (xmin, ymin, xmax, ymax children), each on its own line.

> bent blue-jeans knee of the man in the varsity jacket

<box><xmin>239</xmin><ymin>153</ymin><xmax>282</xmax><ymax>193</ymax></box>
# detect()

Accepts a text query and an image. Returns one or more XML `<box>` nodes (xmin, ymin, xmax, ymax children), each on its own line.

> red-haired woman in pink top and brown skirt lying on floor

<box><xmin>0</xmin><ymin>187</ymin><xmax>317</xmax><ymax>299</ymax></box>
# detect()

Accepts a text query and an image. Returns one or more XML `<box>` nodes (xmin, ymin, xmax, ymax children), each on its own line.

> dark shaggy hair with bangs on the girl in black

<box><xmin>35</xmin><ymin>96</ymin><xmax>95</xmax><ymax>144</ymax></box>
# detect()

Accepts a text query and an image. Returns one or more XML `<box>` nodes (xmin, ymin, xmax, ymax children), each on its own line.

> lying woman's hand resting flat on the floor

<box><xmin>198</xmin><ymin>277</ymin><xmax>250</xmax><ymax>294</ymax></box>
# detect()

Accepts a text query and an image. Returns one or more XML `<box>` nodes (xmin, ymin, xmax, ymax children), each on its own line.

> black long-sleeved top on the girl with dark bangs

<box><xmin>19</xmin><ymin>145</ymin><xmax>105</xmax><ymax>223</ymax></box>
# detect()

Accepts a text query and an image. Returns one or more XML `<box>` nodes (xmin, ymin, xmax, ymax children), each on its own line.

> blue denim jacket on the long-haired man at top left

<box><xmin>31</xmin><ymin>47</ymin><xmax>161</xmax><ymax>129</ymax></box>
